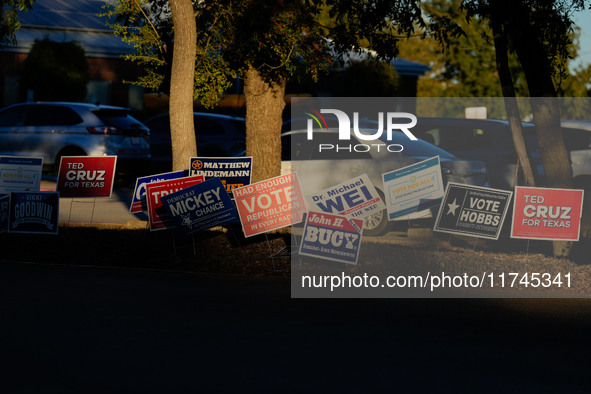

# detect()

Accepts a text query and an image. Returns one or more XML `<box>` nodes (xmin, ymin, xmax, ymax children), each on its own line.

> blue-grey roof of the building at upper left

<box><xmin>2</xmin><ymin>0</ymin><xmax>134</xmax><ymax>57</ymax></box>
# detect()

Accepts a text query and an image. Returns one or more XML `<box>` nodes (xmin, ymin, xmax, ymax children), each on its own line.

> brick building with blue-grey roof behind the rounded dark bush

<box><xmin>0</xmin><ymin>0</ymin><xmax>143</xmax><ymax>110</ymax></box>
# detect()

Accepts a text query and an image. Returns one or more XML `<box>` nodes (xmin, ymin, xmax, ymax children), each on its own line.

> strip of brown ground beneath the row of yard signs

<box><xmin>0</xmin><ymin>225</ymin><xmax>591</xmax><ymax>294</ymax></box>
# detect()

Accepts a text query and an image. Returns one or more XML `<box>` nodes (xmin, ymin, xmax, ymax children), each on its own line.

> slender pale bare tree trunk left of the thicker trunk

<box><xmin>169</xmin><ymin>0</ymin><xmax>197</xmax><ymax>171</ymax></box>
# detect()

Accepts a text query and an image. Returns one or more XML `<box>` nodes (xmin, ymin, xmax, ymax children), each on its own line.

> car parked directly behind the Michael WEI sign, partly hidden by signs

<box><xmin>281</xmin><ymin>129</ymin><xmax>488</xmax><ymax>235</ymax></box>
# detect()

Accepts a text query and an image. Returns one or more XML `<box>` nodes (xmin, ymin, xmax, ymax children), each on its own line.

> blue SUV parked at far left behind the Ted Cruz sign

<box><xmin>0</xmin><ymin>102</ymin><xmax>150</xmax><ymax>173</ymax></box>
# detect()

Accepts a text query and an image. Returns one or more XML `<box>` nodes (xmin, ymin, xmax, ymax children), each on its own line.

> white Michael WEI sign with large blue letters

<box><xmin>312</xmin><ymin>174</ymin><xmax>386</xmax><ymax>219</ymax></box>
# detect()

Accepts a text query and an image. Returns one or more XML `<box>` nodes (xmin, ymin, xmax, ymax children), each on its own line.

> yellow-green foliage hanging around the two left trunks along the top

<box><xmin>105</xmin><ymin>0</ymin><xmax>461</xmax><ymax>104</ymax></box>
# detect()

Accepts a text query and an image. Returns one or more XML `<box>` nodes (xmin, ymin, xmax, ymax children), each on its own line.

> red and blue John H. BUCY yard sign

<box><xmin>299</xmin><ymin>211</ymin><xmax>363</xmax><ymax>264</ymax></box>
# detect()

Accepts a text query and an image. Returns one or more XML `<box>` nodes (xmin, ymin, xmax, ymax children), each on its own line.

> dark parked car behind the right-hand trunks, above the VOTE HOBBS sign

<box><xmin>382</xmin><ymin>118</ymin><xmax>591</xmax><ymax>190</ymax></box>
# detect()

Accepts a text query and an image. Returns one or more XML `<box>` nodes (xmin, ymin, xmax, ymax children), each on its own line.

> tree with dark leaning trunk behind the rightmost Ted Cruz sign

<box><xmin>464</xmin><ymin>0</ymin><xmax>585</xmax><ymax>255</ymax></box>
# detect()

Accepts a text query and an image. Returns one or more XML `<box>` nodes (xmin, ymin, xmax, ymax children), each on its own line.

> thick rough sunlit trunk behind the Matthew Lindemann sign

<box><xmin>244</xmin><ymin>67</ymin><xmax>286</xmax><ymax>182</ymax></box>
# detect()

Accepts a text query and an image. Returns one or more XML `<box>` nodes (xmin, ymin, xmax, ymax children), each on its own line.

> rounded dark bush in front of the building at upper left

<box><xmin>19</xmin><ymin>38</ymin><xmax>89</xmax><ymax>101</ymax></box>
